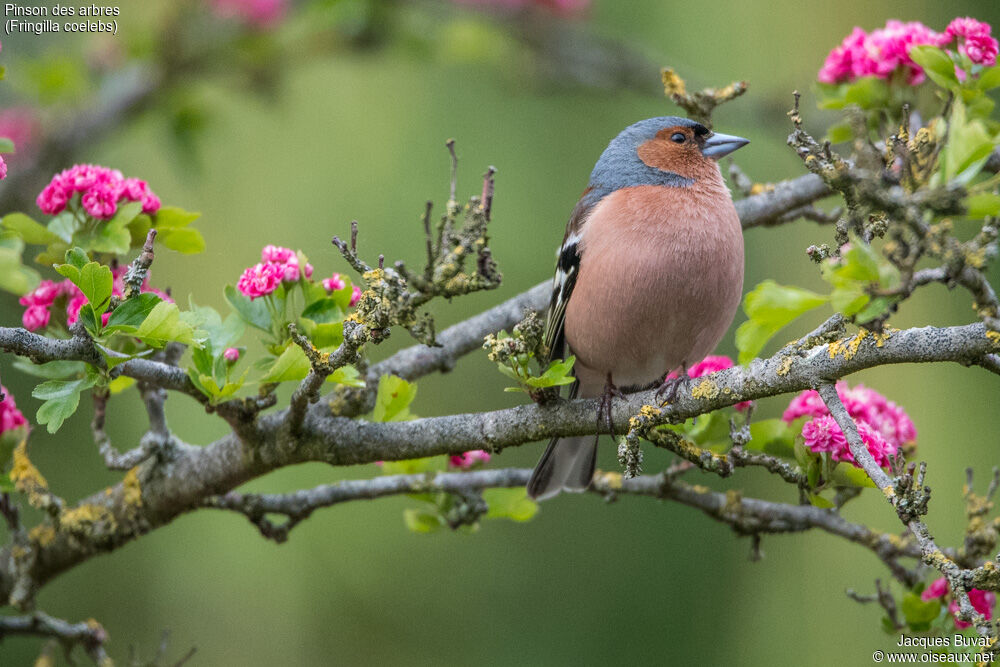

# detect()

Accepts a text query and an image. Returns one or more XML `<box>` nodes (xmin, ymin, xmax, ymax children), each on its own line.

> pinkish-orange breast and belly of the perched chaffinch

<box><xmin>566</xmin><ymin>180</ymin><xmax>743</xmax><ymax>395</ymax></box>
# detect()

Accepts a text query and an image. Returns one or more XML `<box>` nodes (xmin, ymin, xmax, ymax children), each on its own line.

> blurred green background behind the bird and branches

<box><xmin>0</xmin><ymin>0</ymin><xmax>1000</xmax><ymax>666</ymax></box>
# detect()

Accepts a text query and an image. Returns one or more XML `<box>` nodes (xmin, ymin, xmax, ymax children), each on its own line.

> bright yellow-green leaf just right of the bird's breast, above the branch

<box><xmin>736</xmin><ymin>280</ymin><xmax>827</xmax><ymax>364</ymax></box>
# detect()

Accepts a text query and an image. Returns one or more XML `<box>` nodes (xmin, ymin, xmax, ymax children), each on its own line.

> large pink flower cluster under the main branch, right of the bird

<box><xmin>781</xmin><ymin>382</ymin><xmax>917</xmax><ymax>468</ymax></box>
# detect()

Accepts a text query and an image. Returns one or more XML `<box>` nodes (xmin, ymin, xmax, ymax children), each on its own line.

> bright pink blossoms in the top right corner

<box><xmin>818</xmin><ymin>18</ymin><xmax>997</xmax><ymax>85</ymax></box>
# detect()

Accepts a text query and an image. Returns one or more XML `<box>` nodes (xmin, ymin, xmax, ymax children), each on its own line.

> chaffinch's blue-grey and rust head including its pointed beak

<box><xmin>591</xmin><ymin>116</ymin><xmax>750</xmax><ymax>194</ymax></box>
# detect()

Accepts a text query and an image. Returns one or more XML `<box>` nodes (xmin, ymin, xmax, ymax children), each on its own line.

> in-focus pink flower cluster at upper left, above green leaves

<box><xmin>35</xmin><ymin>164</ymin><xmax>160</xmax><ymax>219</ymax></box>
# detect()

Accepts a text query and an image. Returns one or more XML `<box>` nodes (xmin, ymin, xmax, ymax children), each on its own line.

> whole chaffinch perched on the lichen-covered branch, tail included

<box><xmin>527</xmin><ymin>116</ymin><xmax>750</xmax><ymax>500</ymax></box>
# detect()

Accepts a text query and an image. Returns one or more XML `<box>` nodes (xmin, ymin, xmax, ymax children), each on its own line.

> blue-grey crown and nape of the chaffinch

<box><xmin>586</xmin><ymin>116</ymin><xmax>701</xmax><ymax>203</ymax></box>
